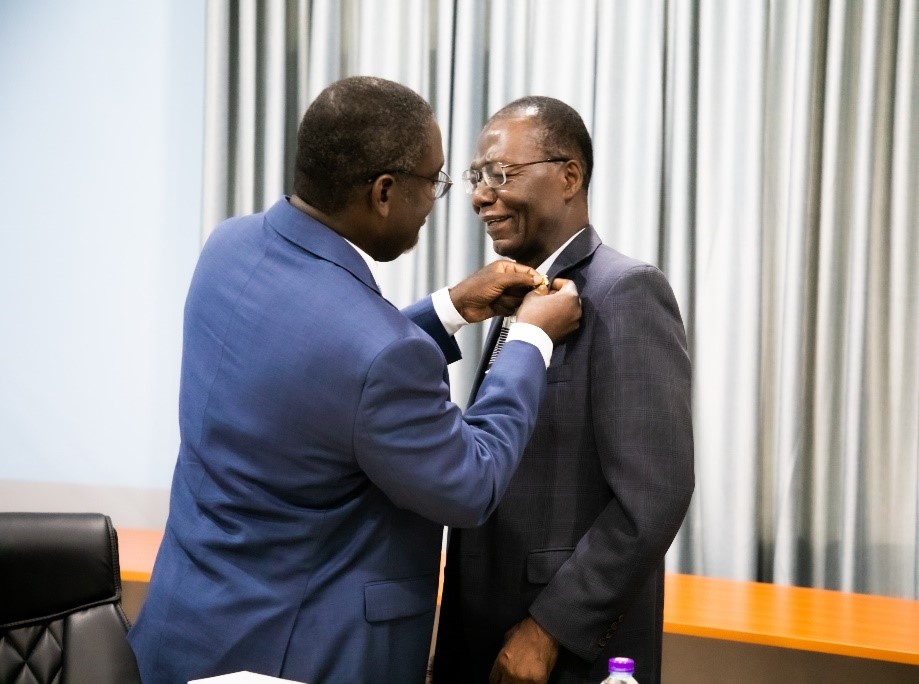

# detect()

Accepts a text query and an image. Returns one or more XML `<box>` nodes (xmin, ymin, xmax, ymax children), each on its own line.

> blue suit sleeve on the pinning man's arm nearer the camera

<box><xmin>354</xmin><ymin>336</ymin><xmax>546</xmax><ymax>527</ymax></box>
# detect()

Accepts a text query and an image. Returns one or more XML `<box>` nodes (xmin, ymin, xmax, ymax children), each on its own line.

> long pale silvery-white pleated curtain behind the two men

<box><xmin>203</xmin><ymin>0</ymin><xmax>919</xmax><ymax>598</ymax></box>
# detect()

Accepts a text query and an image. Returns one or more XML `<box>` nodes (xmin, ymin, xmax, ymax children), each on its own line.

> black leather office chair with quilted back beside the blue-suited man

<box><xmin>0</xmin><ymin>513</ymin><xmax>140</xmax><ymax>684</ymax></box>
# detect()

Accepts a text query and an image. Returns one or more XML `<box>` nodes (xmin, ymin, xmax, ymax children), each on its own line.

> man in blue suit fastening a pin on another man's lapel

<box><xmin>130</xmin><ymin>77</ymin><xmax>580</xmax><ymax>684</ymax></box>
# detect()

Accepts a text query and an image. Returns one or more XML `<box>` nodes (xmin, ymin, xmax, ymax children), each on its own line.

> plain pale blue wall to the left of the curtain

<box><xmin>0</xmin><ymin>0</ymin><xmax>205</xmax><ymax>520</ymax></box>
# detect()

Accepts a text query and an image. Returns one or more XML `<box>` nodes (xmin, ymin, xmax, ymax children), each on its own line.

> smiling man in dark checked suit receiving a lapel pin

<box><xmin>433</xmin><ymin>97</ymin><xmax>694</xmax><ymax>684</ymax></box>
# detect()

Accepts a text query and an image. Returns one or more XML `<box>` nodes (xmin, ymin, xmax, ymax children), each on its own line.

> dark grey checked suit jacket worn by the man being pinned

<box><xmin>434</xmin><ymin>226</ymin><xmax>694</xmax><ymax>684</ymax></box>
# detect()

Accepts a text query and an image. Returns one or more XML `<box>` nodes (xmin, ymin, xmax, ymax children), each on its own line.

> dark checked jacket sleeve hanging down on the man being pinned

<box><xmin>530</xmin><ymin>266</ymin><xmax>694</xmax><ymax>660</ymax></box>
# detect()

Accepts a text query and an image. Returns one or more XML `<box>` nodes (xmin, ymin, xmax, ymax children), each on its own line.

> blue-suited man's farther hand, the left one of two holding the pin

<box><xmin>450</xmin><ymin>259</ymin><xmax>543</xmax><ymax>323</ymax></box>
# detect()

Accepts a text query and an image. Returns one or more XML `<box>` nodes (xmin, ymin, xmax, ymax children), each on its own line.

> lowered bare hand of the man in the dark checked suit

<box><xmin>488</xmin><ymin>617</ymin><xmax>558</xmax><ymax>684</ymax></box>
